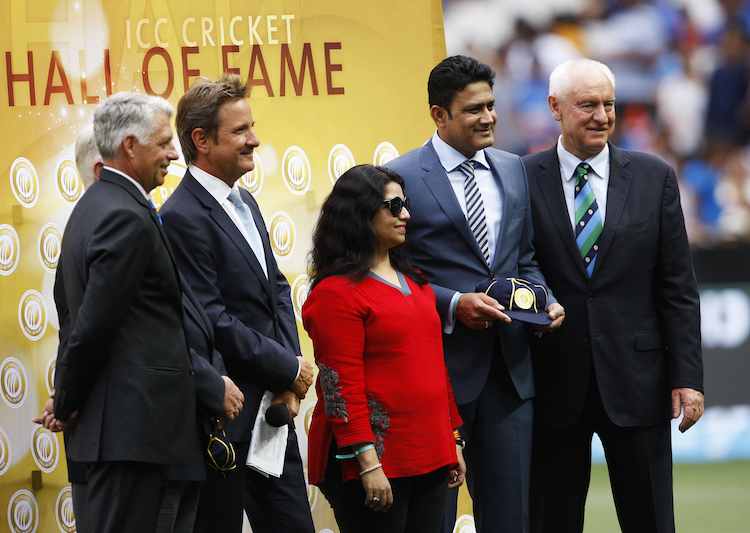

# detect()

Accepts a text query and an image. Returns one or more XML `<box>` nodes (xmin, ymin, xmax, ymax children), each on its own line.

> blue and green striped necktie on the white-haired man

<box><xmin>574</xmin><ymin>163</ymin><xmax>604</xmax><ymax>277</ymax></box>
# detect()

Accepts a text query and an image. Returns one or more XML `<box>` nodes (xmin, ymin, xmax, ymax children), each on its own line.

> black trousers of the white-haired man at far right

<box><xmin>531</xmin><ymin>379</ymin><xmax>675</xmax><ymax>533</ymax></box>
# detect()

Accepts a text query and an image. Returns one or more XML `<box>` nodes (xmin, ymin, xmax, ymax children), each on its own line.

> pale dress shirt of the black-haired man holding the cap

<box><xmin>432</xmin><ymin>132</ymin><xmax>503</xmax><ymax>262</ymax></box>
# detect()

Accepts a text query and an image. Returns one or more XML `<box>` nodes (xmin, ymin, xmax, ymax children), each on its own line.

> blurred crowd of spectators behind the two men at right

<box><xmin>444</xmin><ymin>0</ymin><xmax>750</xmax><ymax>247</ymax></box>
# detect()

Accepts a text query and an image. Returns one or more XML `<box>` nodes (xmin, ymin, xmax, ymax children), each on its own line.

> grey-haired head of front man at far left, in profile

<box><xmin>94</xmin><ymin>92</ymin><xmax>178</xmax><ymax>192</ymax></box>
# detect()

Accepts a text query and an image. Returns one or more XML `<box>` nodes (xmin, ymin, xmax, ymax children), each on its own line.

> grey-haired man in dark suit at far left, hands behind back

<box><xmin>54</xmin><ymin>93</ymin><xmax>201</xmax><ymax>532</ymax></box>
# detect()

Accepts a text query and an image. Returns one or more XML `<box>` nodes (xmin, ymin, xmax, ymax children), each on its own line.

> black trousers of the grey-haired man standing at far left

<box><xmin>84</xmin><ymin>462</ymin><xmax>165</xmax><ymax>533</ymax></box>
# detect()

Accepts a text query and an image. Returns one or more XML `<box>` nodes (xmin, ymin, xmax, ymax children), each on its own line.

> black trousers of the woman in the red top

<box><xmin>321</xmin><ymin>468</ymin><xmax>448</xmax><ymax>533</ymax></box>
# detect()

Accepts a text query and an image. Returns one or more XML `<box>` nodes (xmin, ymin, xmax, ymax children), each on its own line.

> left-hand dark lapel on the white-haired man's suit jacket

<box><xmin>539</xmin><ymin>148</ymin><xmax>586</xmax><ymax>277</ymax></box>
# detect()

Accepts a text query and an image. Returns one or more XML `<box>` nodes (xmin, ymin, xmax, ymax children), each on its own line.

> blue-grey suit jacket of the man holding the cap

<box><xmin>387</xmin><ymin>142</ymin><xmax>545</xmax><ymax>404</ymax></box>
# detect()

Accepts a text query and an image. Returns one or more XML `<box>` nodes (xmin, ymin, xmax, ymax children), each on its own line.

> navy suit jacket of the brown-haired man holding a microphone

<box><xmin>160</xmin><ymin>172</ymin><xmax>300</xmax><ymax>442</ymax></box>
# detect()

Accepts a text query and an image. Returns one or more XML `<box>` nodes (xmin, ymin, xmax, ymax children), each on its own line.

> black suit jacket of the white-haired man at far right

<box><xmin>524</xmin><ymin>145</ymin><xmax>703</xmax><ymax>426</ymax></box>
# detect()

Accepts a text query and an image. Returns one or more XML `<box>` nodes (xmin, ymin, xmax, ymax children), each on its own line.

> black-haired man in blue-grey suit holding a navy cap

<box><xmin>388</xmin><ymin>56</ymin><xmax>563</xmax><ymax>533</ymax></box>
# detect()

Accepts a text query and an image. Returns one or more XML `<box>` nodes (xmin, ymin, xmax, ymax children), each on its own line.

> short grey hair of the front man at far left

<box><xmin>94</xmin><ymin>92</ymin><xmax>173</xmax><ymax>159</ymax></box>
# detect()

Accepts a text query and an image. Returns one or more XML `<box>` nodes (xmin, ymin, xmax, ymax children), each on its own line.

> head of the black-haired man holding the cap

<box><xmin>427</xmin><ymin>55</ymin><xmax>497</xmax><ymax>157</ymax></box>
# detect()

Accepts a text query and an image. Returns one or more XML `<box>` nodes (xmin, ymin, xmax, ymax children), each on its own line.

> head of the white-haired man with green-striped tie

<box><xmin>547</xmin><ymin>59</ymin><xmax>615</xmax><ymax>159</ymax></box>
